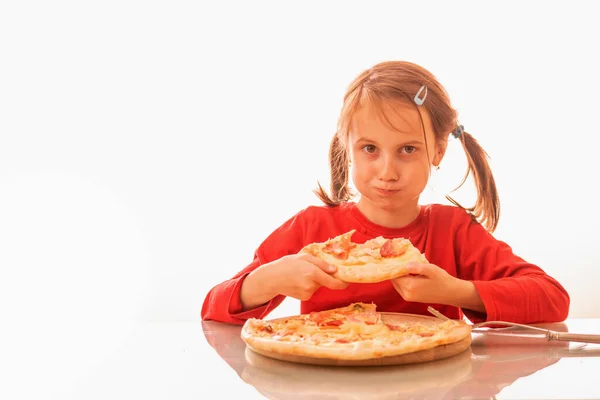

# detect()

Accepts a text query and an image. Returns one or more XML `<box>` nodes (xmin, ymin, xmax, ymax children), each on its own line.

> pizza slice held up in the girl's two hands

<box><xmin>299</xmin><ymin>230</ymin><xmax>429</xmax><ymax>283</ymax></box>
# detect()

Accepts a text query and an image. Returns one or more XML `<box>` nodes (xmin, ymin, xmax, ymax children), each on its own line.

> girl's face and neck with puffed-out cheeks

<box><xmin>348</xmin><ymin>101</ymin><xmax>445</xmax><ymax>219</ymax></box>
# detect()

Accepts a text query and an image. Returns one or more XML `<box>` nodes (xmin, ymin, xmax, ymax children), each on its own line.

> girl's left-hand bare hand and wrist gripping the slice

<box><xmin>240</xmin><ymin>254</ymin><xmax>348</xmax><ymax>309</ymax></box>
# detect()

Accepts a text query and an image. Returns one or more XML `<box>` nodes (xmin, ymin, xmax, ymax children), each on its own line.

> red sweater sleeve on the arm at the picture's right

<box><xmin>455</xmin><ymin>213</ymin><xmax>570</xmax><ymax>324</ymax></box>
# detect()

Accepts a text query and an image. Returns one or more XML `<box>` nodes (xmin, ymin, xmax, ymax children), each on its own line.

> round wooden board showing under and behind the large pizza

<box><xmin>247</xmin><ymin>313</ymin><xmax>471</xmax><ymax>366</ymax></box>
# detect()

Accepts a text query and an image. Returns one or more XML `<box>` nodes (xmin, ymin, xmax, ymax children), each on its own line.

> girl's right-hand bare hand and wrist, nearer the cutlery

<box><xmin>391</xmin><ymin>263</ymin><xmax>472</xmax><ymax>306</ymax></box>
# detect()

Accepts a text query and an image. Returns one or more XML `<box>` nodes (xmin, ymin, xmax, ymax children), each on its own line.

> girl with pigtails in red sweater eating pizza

<box><xmin>201</xmin><ymin>61</ymin><xmax>570</xmax><ymax>324</ymax></box>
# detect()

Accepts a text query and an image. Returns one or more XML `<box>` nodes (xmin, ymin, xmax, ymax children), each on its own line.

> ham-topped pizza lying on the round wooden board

<box><xmin>241</xmin><ymin>303</ymin><xmax>471</xmax><ymax>363</ymax></box>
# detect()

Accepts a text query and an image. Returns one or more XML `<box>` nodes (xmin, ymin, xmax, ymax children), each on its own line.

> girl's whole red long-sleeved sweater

<box><xmin>201</xmin><ymin>202</ymin><xmax>570</xmax><ymax>324</ymax></box>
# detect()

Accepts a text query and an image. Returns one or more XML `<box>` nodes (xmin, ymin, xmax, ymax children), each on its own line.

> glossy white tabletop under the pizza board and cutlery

<box><xmin>0</xmin><ymin>319</ymin><xmax>600</xmax><ymax>399</ymax></box>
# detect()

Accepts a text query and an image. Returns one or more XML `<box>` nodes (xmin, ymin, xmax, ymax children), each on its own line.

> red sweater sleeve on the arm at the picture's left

<box><xmin>200</xmin><ymin>211</ymin><xmax>305</xmax><ymax>325</ymax></box>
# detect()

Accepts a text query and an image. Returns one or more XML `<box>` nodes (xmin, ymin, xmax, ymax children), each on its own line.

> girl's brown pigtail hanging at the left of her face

<box><xmin>313</xmin><ymin>134</ymin><xmax>352</xmax><ymax>207</ymax></box>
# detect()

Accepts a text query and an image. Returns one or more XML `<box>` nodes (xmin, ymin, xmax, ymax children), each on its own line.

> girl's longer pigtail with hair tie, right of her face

<box><xmin>446</xmin><ymin>131</ymin><xmax>500</xmax><ymax>233</ymax></box>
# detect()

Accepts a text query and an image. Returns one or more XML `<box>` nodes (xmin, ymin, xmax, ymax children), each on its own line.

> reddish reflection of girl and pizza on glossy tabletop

<box><xmin>203</xmin><ymin>320</ymin><xmax>600</xmax><ymax>400</ymax></box>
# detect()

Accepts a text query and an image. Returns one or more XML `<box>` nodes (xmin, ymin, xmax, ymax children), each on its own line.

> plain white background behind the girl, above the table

<box><xmin>0</xmin><ymin>1</ymin><xmax>600</xmax><ymax>396</ymax></box>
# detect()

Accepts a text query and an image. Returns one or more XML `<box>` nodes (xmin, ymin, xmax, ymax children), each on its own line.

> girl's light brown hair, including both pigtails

<box><xmin>314</xmin><ymin>61</ymin><xmax>500</xmax><ymax>232</ymax></box>
